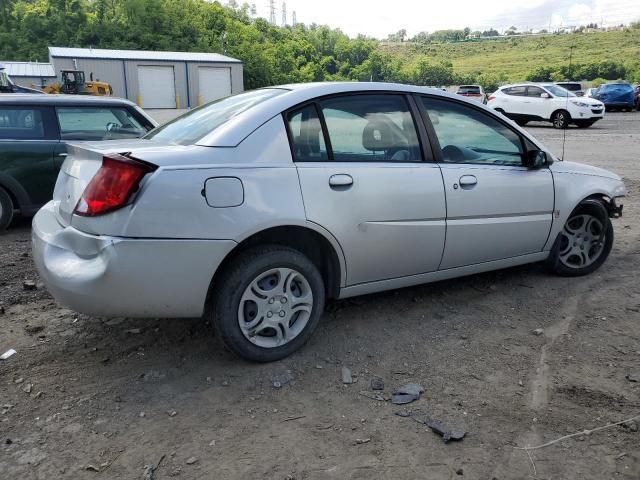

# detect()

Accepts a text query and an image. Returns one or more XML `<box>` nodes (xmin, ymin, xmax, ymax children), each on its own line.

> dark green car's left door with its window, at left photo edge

<box><xmin>0</xmin><ymin>104</ymin><xmax>59</xmax><ymax>213</ymax></box>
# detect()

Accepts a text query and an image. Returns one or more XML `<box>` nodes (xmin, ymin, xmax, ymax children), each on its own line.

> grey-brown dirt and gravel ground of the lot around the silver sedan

<box><xmin>0</xmin><ymin>113</ymin><xmax>640</xmax><ymax>480</ymax></box>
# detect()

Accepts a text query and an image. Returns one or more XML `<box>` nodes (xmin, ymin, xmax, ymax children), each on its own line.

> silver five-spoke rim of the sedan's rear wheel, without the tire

<box><xmin>238</xmin><ymin>268</ymin><xmax>313</xmax><ymax>348</ymax></box>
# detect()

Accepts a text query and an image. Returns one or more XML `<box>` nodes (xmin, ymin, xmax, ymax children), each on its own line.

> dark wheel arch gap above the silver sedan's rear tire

<box><xmin>206</xmin><ymin>222</ymin><xmax>346</xmax><ymax>314</ymax></box>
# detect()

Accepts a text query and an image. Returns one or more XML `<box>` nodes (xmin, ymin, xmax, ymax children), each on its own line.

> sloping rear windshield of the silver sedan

<box><xmin>144</xmin><ymin>88</ymin><xmax>287</xmax><ymax>145</ymax></box>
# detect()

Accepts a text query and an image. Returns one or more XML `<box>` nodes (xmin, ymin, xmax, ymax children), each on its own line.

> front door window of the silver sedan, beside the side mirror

<box><xmin>422</xmin><ymin>97</ymin><xmax>523</xmax><ymax>166</ymax></box>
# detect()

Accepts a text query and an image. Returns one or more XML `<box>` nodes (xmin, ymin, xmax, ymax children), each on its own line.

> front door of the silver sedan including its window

<box><xmin>422</xmin><ymin>97</ymin><xmax>554</xmax><ymax>269</ymax></box>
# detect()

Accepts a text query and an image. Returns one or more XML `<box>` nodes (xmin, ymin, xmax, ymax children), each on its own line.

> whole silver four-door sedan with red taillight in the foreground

<box><xmin>33</xmin><ymin>83</ymin><xmax>625</xmax><ymax>361</ymax></box>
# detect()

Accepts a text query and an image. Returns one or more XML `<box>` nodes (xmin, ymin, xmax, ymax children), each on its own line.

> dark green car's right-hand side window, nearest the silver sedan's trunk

<box><xmin>56</xmin><ymin>107</ymin><xmax>147</xmax><ymax>140</ymax></box>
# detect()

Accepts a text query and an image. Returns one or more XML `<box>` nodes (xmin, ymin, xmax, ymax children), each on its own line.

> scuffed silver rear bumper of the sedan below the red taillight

<box><xmin>32</xmin><ymin>202</ymin><xmax>236</xmax><ymax>317</ymax></box>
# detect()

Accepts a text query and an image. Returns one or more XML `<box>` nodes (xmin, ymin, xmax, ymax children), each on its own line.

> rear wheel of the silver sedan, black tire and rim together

<box><xmin>212</xmin><ymin>245</ymin><xmax>325</xmax><ymax>362</ymax></box>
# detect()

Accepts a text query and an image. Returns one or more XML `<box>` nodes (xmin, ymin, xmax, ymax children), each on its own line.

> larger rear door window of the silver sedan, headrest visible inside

<box><xmin>319</xmin><ymin>95</ymin><xmax>422</xmax><ymax>162</ymax></box>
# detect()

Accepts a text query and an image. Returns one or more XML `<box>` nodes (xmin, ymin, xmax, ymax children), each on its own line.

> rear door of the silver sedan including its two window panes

<box><xmin>285</xmin><ymin>93</ymin><xmax>446</xmax><ymax>285</ymax></box>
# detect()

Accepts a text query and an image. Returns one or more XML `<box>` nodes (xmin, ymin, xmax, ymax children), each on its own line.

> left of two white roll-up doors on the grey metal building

<box><xmin>138</xmin><ymin>65</ymin><xmax>176</xmax><ymax>108</ymax></box>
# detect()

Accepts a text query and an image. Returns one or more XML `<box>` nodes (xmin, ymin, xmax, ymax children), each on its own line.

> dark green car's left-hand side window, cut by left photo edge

<box><xmin>0</xmin><ymin>106</ymin><xmax>51</xmax><ymax>140</ymax></box>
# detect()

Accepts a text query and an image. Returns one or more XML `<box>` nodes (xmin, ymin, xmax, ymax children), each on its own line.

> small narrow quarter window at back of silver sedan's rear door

<box><xmin>287</xmin><ymin>105</ymin><xmax>328</xmax><ymax>162</ymax></box>
